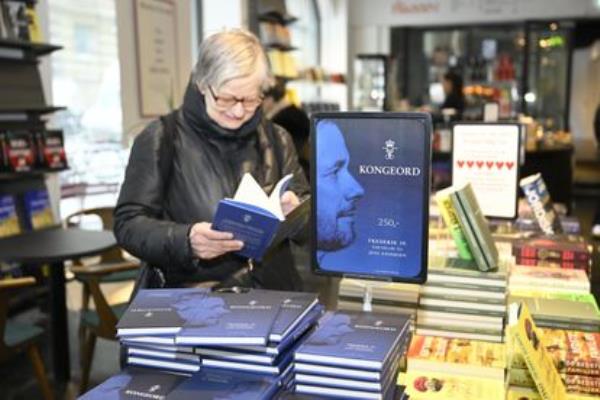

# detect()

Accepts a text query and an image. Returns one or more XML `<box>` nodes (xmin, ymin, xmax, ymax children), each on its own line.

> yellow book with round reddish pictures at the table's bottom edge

<box><xmin>398</xmin><ymin>369</ymin><xmax>506</xmax><ymax>400</ymax></box>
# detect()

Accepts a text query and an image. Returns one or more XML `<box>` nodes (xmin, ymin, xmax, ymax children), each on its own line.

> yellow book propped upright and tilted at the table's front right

<box><xmin>507</xmin><ymin>303</ymin><xmax>567</xmax><ymax>400</ymax></box>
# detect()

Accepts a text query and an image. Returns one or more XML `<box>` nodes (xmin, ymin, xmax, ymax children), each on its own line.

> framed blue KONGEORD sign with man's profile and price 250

<box><xmin>311</xmin><ymin>113</ymin><xmax>431</xmax><ymax>283</ymax></box>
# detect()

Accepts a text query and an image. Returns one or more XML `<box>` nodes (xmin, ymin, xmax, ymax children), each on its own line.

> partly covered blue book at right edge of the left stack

<box><xmin>269</xmin><ymin>292</ymin><xmax>319</xmax><ymax>343</ymax></box>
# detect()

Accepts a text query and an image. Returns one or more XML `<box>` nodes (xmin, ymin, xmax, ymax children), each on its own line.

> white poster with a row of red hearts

<box><xmin>452</xmin><ymin>123</ymin><xmax>520</xmax><ymax>218</ymax></box>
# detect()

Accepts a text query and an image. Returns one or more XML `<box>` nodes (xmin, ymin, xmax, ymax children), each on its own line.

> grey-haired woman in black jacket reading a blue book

<box><xmin>114</xmin><ymin>30</ymin><xmax>309</xmax><ymax>290</ymax></box>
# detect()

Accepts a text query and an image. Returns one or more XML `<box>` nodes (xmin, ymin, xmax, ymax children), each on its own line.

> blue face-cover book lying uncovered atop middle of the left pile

<box><xmin>175</xmin><ymin>289</ymin><xmax>284</xmax><ymax>346</ymax></box>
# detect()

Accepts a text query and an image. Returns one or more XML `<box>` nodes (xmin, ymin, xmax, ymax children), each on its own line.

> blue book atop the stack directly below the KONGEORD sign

<box><xmin>295</xmin><ymin>311</ymin><xmax>410</xmax><ymax>371</ymax></box>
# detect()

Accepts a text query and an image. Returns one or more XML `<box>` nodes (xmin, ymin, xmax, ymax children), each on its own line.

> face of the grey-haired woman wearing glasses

<box><xmin>202</xmin><ymin>68</ymin><xmax>263</xmax><ymax>129</ymax></box>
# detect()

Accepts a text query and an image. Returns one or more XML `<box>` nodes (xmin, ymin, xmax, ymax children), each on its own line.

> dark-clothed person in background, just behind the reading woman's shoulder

<box><xmin>263</xmin><ymin>78</ymin><xmax>310</xmax><ymax>177</ymax></box>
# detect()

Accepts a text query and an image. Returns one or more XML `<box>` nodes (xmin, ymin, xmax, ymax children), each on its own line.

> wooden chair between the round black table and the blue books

<box><xmin>65</xmin><ymin>207</ymin><xmax>139</xmax><ymax>393</ymax></box>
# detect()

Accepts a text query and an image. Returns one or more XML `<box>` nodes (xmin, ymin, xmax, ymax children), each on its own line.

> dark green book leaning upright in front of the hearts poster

<box><xmin>449</xmin><ymin>183</ymin><xmax>498</xmax><ymax>271</ymax></box>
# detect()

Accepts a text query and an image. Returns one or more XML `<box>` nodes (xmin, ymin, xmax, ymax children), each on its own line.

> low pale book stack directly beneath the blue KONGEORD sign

<box><xmin>337</xmin><ymin>278</ymin><xmax>419</xmax><ymax>329</ymax></box>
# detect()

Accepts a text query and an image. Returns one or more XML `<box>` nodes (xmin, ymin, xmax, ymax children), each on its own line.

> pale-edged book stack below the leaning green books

<box><xmin>416</xmin><ymin>258</ymin><xmax>507</xmax><ymax>342</ymax></box>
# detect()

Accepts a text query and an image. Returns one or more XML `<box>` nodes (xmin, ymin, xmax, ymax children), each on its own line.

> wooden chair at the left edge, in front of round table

<box><xmin>0</xmin><ymin>277</ymin><xmax>54</xmax><ymax>400</ymax></box>
